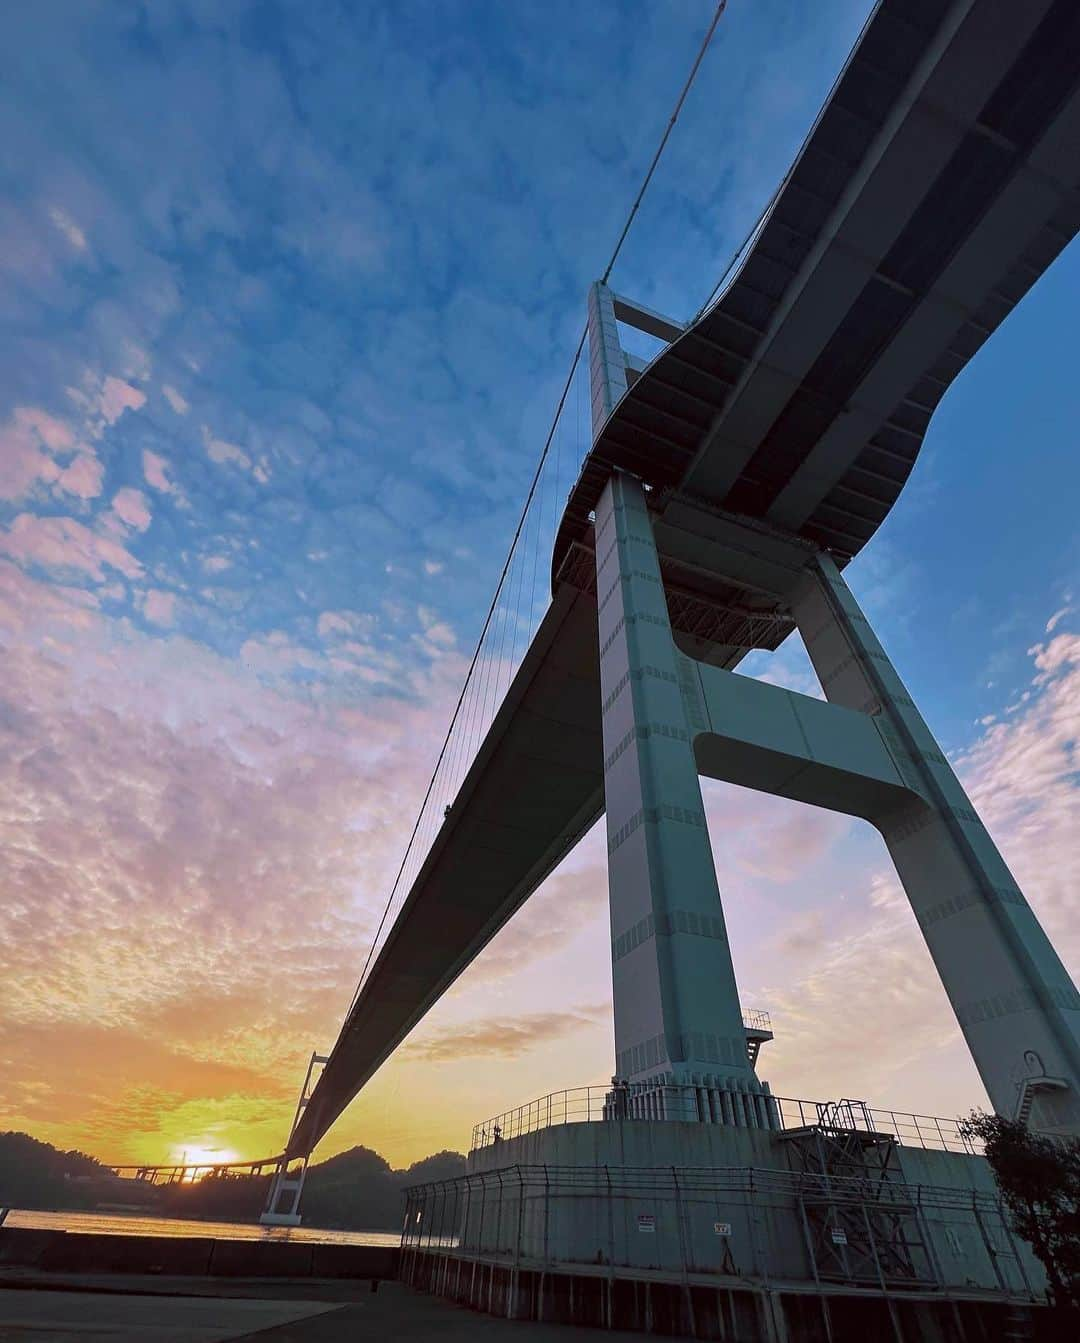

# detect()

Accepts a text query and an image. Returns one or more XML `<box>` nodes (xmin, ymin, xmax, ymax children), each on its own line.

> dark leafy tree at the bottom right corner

<box><xmin>963</xmin><ymin>1109</ymin><xmax>1080</xmax><ymax>1311</ymax></box>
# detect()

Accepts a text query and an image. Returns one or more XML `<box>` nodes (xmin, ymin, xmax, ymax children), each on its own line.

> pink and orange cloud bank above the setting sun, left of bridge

<box><xmin>0</xmin><ymin>564</ymin><xmax>462</xmax><ymax>1159</ymax></box>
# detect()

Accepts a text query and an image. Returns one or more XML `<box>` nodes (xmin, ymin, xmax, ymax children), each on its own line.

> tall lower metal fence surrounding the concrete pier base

<box><xmin>400</xmin><ymin>1164</ymin><xmax>1041</xmax><ymax>1305</ymax></box>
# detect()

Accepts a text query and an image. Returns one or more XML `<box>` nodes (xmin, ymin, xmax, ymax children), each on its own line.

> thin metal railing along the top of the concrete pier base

<box><xmin>470</xmin><ymin>1090</ymin><xmax>982</xmax><ymax>1156</ymax></box>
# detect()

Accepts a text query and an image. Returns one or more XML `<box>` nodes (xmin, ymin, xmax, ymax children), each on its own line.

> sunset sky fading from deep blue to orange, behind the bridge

<box><xmin>0</xmin><ymin>0</ymin><xmax>1080</xmax><ymax>1166</ymax></box>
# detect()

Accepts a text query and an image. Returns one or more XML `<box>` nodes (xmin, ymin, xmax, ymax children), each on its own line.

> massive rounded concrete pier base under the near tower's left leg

<box><xmin>400</xmin><ymin>1120</ymin><xmax>1045</xmax><ymax>1343</ymax></box>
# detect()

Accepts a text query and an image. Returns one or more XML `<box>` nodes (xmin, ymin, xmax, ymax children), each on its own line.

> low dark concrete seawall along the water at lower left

<box><xmin>0</xmin><ymin>1226</ymin><xmax>398</xmax><ymax>1279</ymax></box>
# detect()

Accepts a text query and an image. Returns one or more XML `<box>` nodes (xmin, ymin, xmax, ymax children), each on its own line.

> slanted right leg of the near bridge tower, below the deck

<box><xmin>789</xmin><ymin>553</ymin><xmax>1080</xmax><ymax>1133</ymax></box>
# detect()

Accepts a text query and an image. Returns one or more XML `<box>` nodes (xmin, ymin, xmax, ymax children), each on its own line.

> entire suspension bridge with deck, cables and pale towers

<box><xmin>101</xmin><ymin>0</ymin><xmax>1080</xmax><ymax>1251</ymax></box>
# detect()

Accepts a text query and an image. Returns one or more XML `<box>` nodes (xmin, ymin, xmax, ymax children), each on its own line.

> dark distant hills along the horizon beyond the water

<box><xmin>0</xmin><ymin>1132</ymin><xmax>465</xmax><ymax>1232</ymax></box>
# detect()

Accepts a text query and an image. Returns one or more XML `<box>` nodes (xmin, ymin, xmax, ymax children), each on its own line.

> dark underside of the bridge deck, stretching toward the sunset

<box><xmin>290</xmin><ymin>0</ymin><xmax>1080</xmax><ymax>1155</ymax></box>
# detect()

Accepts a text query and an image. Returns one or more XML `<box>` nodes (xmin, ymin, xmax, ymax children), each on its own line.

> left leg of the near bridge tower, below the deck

<box><xmin>596</xmin><ymin>473</ymin><xmax>760</xmax><ymax>1092</ymax></box>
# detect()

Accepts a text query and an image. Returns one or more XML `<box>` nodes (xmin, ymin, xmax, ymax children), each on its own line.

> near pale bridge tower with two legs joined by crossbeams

<box><xmin>588</xmin><ymin>283</ymin><xmax>1080</xmax><ymax>1133</ymax></box>
